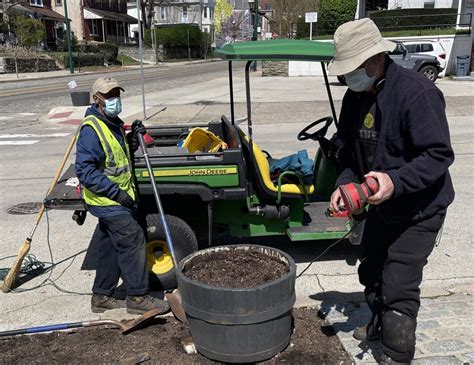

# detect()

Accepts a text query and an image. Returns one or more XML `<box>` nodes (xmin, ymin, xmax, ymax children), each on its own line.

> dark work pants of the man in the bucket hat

<box><xmin>358</xmin><ymin>210</ymin><xmax>444</xmax><ymax>358</ymax></box>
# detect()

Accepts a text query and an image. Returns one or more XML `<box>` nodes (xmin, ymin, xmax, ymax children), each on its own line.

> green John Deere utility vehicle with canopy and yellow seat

<box><xmin>46</xmin><ymin>39</ymin><xmax>350</xmax><ymax>288</ymax></box>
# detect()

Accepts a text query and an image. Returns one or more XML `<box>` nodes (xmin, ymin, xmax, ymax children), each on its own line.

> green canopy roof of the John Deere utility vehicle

<box><xmin>214</xmin><ymin>39</ymin><xmax>334</xmax><ymax>62</ymax></box>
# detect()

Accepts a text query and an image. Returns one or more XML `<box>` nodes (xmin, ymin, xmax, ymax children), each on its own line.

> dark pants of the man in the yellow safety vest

<box><xmin>92</xmin><ymin>213</ymin><xmax>148</xmax><ymax>296</ymax></box>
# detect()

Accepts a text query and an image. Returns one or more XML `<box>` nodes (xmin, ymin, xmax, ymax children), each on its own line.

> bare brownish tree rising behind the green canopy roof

<box><xmin>270</xmin><ymin>0</ymin><xmax>319</xmax><ymax>38</ymax></box>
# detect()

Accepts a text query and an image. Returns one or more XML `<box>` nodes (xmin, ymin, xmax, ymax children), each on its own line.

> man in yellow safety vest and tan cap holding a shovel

<box><xmin>75</xmin><ymin>77</ymin><xmax>169</xmax><ymax>314</ymax></box>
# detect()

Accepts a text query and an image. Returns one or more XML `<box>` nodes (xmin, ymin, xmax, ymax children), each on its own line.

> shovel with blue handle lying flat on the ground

<box><xmin>0</xmin><ymin>308</ymin><xmax>165</xmax><ymax>337</ymax></box>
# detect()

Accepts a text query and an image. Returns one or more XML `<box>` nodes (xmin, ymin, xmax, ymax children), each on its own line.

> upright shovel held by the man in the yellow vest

<box><xmin>138</xmin><ymin>127</ymin><xmax>187</xmax><ymax>323</ymax></box>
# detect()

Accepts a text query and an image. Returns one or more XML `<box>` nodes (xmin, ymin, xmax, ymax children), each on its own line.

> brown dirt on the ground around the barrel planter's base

<box><xmin>0</xmin><ymin>308</ymin><xmax>351</xmax><ymax>365</ymax></box>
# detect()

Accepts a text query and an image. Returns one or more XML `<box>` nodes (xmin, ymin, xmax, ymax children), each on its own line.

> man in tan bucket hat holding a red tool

<box><xmin>329</xmin><ymin>19</ymin><xmax>454</xmax><ymax>364</ymax></box>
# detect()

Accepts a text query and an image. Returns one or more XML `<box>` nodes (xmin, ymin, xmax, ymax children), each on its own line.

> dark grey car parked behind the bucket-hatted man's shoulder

<box><xmin>337</xmin><ymin>42</ymin><xmax>443</xmax><ymax>85</ymax></box>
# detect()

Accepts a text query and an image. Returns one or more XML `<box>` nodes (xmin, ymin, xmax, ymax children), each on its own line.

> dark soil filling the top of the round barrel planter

<box><xmin>183</xmin><ymin>248</ymin><xmax>290</xmax><ymax>288</ymax></box>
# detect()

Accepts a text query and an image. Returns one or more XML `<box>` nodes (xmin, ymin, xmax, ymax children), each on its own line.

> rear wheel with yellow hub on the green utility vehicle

<box><xmin>146</xmin><ymin>214</ymin><xmax>198</xmax><ymax>290</ymax></box>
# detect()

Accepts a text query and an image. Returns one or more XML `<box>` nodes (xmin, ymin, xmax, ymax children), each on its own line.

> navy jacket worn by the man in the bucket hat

<box><xmin>336</xmin><ymin>57</ymin><xmax>454</xmax><ymax>221</ymax></box>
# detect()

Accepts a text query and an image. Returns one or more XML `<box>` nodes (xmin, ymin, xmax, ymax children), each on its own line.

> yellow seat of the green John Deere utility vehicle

<box><xmin>234</xmin><ymin>126</ymin><xmax>315</xmax><ymax>197</ymax></box>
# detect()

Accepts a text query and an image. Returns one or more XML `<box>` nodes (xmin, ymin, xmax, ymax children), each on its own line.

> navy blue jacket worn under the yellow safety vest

<box><xmin>75</xmin><ymin>104</ymin><xmax>130</xmax><ymax>218</ymax></box>
